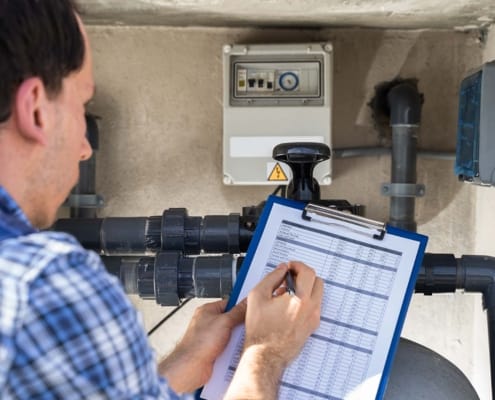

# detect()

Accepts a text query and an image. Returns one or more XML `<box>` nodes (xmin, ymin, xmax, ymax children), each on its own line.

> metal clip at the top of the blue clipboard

<box><xmin>302</xmin><ymin>203</ymin><xmax>386</xmax><ymax>240</ymax></box>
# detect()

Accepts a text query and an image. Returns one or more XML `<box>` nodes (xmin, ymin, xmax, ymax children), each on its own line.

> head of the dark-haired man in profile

<box><xmin>0</xmin><ymin>0</ymin><xmax>94</xmax><ymax>227</ymax></box>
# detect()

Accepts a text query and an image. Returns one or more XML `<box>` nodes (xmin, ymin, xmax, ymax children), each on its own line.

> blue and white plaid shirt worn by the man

<box><xmin>0</xmin><ymin>187</ymin><xmax>191</xmax><ymax>400</ymax></box>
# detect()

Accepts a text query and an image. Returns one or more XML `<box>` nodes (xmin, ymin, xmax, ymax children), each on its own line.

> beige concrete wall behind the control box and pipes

<box><xmin>85</xmin><ymin>26</ymin><xmax>495</xmax><ymax>399</ymax></box>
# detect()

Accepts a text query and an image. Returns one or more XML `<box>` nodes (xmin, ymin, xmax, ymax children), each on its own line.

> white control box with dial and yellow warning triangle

<box><xmin>223</xmin><ymin>43</ymin><xmax>333</xmax><ymax>185</ymax></box>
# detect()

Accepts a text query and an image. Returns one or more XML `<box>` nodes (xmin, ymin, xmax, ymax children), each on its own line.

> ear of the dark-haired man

<box><xmin>14</xmin><ymin>78</ymin><xmax>50</xmax><ymax>145</ymax></box>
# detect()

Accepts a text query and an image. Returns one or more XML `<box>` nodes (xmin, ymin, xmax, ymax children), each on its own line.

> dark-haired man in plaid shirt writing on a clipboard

<box><xmin>0</xmin><ymin>0</ymin><xmax>323</xmax><ymax>400</ymax></box>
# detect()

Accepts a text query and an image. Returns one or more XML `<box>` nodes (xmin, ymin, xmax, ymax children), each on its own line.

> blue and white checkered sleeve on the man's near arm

<box><xmin>9</xmin><ymin>248</ymin><xmax>194</xmax><ymax>400</ymax></box>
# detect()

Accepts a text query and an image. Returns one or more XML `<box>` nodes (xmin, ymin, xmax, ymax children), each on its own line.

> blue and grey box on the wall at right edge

<box><xmin>455</xmin><ymin>61</ymin><xmax>495</xmax><ymax>186</ymax></box>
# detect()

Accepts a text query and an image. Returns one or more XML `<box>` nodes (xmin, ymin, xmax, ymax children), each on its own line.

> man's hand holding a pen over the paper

<box><xmin>225</xmin><ymin>262</ymin><xmax>323</xmax><ymax>400</ymax></box>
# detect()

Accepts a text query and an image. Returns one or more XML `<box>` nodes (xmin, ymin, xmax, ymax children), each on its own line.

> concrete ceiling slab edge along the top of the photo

<box><xmin>78</xmin><ymin>0</ymin><xmax>495</xmax><ymax>29</ymax></box>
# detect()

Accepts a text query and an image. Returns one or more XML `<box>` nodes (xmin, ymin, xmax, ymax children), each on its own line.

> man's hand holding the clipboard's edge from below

<box><xmin>159</xmin><ymin>300</ymin><xmax>246</xmax><ymax>393</ymax></box>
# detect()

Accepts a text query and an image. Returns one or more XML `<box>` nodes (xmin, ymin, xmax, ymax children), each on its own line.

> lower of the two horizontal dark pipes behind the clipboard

<box><xmin>102</xmin><ymin>252</ymin><xmax>495</xmax><ymax>399</ymax></box>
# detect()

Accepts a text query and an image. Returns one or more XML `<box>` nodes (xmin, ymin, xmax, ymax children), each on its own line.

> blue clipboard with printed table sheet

<box><xmin>201</xmin><ymin>196</ymin><xmax>427</xmax><ymax>400</ymax></box>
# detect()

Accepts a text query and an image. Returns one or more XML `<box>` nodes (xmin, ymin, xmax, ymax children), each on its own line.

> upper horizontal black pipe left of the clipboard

<box><xmin>53</xmin><ymin>209</ymin><xmax>257</xmax><ymax>255</ymax></box>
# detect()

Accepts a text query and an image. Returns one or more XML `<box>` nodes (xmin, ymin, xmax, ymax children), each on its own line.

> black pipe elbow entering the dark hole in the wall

<box><xmin>387</xmin><ymin>82</ymin><xmax>423</xmax><ymax>126</ymax></box>
